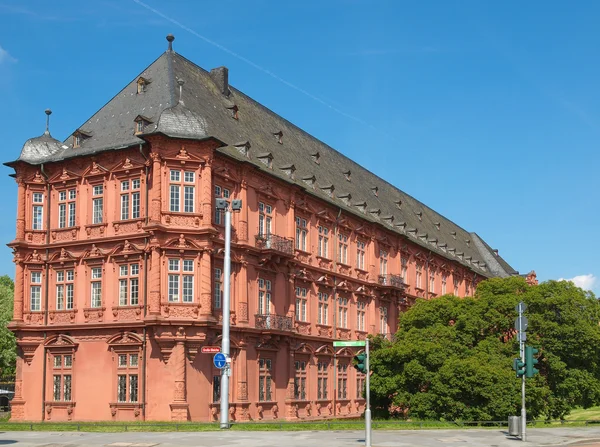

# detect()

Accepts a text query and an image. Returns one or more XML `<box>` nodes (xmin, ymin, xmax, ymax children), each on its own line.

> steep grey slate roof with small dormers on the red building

<box><xmin>8</xmin><ymin>38</ymin><xmax>518</xmax><ymax>276</ymax></box>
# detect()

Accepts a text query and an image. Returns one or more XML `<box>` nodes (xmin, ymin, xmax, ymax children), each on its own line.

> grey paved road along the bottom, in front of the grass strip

<box><xmin>0</xmin><ymin>428</ymin><xmax>600</xmax><ymax>447</ymax></box>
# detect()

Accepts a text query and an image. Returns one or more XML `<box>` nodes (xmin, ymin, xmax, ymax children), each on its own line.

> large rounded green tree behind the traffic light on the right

<box><xmin>371</xmin><ymin>277</ymin><xmax>600</xmax><ymax>420</ymax></box>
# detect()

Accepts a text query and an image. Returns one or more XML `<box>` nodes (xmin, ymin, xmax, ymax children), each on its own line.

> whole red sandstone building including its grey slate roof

<box><xmin>7</xmin><ymin>36</ymin><xmax>517</xmax><ymax>421</ymax></box>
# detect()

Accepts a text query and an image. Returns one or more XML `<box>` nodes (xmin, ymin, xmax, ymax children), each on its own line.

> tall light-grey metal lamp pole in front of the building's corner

<box><xmin>220</xmin><ymin>206</ymin><xmax>231</xmax><ymax>428</ymax></box>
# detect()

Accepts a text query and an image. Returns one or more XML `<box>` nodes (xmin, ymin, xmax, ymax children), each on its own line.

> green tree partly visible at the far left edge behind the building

<box><xmin>0</xmin><ymin>275</ymin><xmax>17</xmax><ymax>375</ymax></box>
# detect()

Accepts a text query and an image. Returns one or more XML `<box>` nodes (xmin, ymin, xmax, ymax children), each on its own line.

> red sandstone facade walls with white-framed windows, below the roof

<box><xmin>9</xmin><ymin>38</ymin><xmax>500</xmax><ymax>421</ymax></box>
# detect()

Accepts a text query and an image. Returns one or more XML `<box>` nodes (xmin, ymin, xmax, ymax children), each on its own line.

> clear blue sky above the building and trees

<box><xmin>0</xmin><ymin>0</ymin><xmax>600</xmax><ymax>293</ymax></box>
